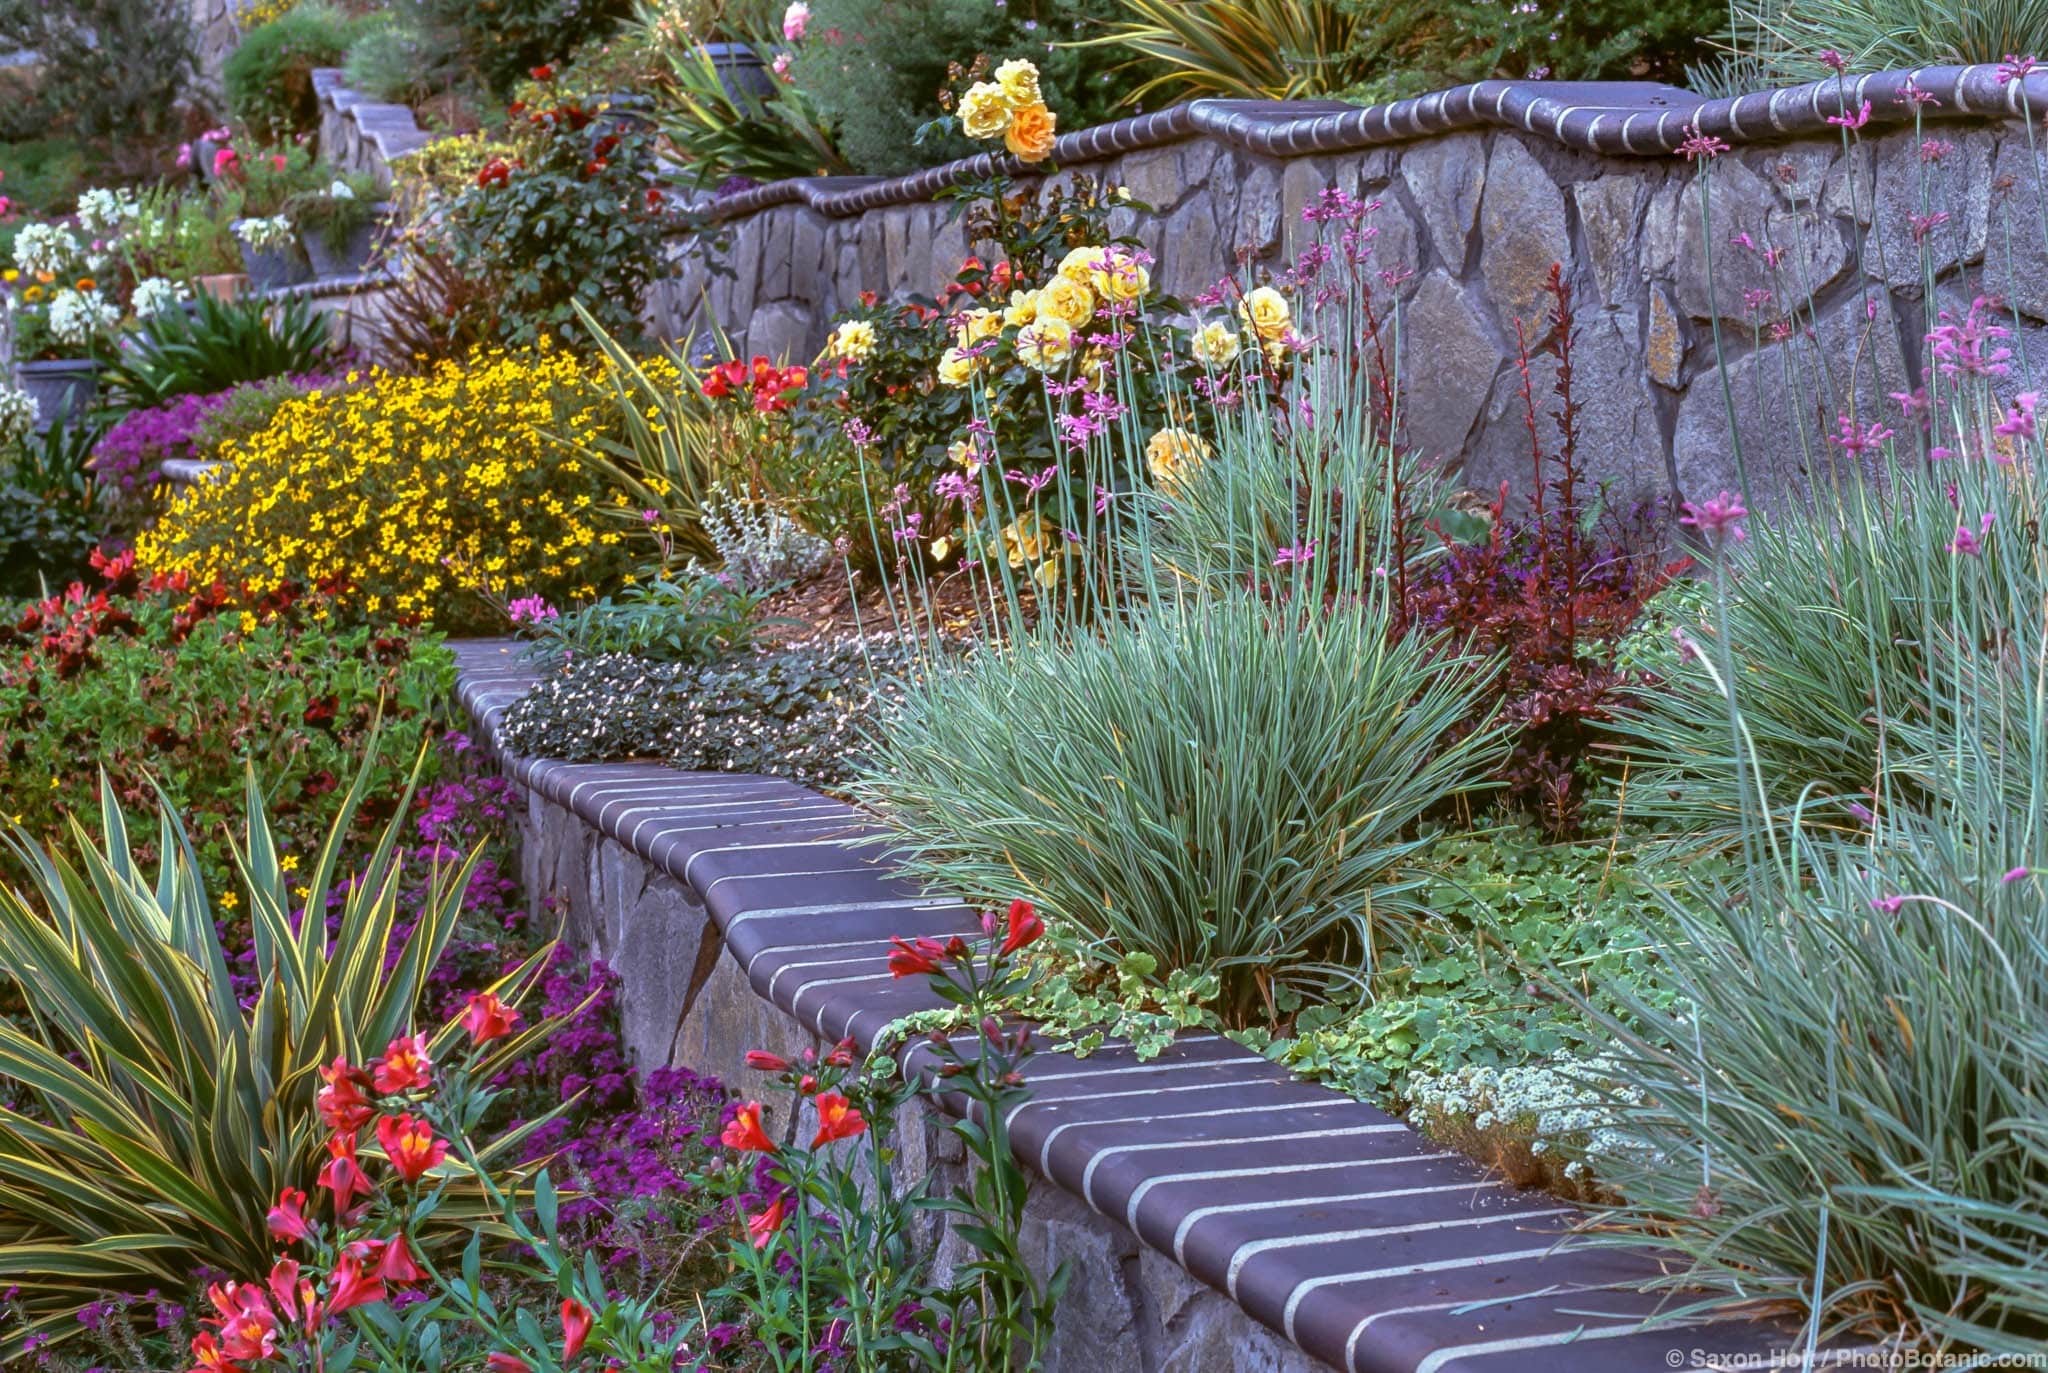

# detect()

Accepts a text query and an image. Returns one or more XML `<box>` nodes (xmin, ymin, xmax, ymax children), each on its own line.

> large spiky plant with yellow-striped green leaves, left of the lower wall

<box><xmin>0</xmin><ymin>754</ymin><xmax>551</xmax><ymax>1348</ymax></box>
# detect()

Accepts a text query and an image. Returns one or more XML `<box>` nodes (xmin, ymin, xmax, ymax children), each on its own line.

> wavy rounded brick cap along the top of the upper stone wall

<box><xmin>711</xmin><ymin>64</ymin><xmax>2048</xmax><ymax>219</ymax></box>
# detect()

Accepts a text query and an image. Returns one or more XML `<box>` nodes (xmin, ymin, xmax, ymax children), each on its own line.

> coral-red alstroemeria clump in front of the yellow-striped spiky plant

<box><xmin>190</xmin><ymin>992</ymin><xmax>696</xmax><ymax>1373</ymax></box>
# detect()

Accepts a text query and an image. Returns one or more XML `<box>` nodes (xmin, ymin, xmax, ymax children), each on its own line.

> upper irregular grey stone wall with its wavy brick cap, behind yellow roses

<box><xmin>657</xmin><ymin>68</ymin><xmax>2048</xmax><ymax>508</ymax></box>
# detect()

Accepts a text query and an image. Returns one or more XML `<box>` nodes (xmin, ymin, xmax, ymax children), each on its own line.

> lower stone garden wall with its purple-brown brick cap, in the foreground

<box><xmin>457</xmin><ymin>641</ymin><xmax>1851</xmax><ymax>1373</ymax></box>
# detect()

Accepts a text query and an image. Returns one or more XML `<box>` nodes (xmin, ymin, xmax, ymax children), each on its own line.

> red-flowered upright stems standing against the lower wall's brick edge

<box><xmin>696</xmin><ymin>900</ymin><xmax>1065</xmax><ymax>1369</ymax></box>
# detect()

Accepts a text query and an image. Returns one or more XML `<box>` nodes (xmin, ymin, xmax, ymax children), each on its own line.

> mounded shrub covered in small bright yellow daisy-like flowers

<box><xmin>137</xmin><ymin>348</ymin><xmax>629</xmax><ymax>631</ymax></box>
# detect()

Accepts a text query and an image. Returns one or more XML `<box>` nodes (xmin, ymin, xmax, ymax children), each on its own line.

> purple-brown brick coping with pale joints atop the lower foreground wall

<box><xmin>453</xmin><ymin>639</ymin><xmax>1851</xmax><ymax>1373</ymax></box>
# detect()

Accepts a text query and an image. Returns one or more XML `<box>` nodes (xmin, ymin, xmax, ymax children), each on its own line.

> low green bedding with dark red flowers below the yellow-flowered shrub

<box><xmin>0</xmin><ymin>553</ymin><xmax>455</xmax><ymax>901</ymax></box>
